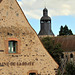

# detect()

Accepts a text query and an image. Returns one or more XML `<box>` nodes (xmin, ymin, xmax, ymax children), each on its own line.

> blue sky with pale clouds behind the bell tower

<box><xmin>17</xmin><ymin>0</ymin><xmax>75</xmax><ymax>36</ymax></box>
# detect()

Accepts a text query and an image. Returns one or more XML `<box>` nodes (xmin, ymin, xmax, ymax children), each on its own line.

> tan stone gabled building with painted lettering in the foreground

<box><xmin>0</xmin><ymin>0</ymin><xmax>58</xmax><ymax>75</ymax></box>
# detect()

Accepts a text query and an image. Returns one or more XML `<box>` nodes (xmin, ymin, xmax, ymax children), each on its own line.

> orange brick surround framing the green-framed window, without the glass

<box><xmin>5</xmin><ymin>38</ymin><xmax>21</xmax><ymax>54</ymax></box>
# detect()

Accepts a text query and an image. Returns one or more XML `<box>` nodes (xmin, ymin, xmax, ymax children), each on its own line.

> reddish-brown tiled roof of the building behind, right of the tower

<box><xmin>53</xmin><ymin>35</ymin><xmax>75</xmax><ymax>51</ymax></box>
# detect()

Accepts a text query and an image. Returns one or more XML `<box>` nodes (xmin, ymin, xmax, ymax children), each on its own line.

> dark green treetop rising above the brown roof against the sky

<box><xmin>59</xmin><ymin>25</ymin><xmax>73</xmax><ymax>36</ymax></box>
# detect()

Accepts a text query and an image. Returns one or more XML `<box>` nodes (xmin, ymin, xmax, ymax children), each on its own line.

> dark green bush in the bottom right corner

<box><xmin>66</xmin><ymin>62</ymin><xmax>75</xmax><ymax>75</ymax></box>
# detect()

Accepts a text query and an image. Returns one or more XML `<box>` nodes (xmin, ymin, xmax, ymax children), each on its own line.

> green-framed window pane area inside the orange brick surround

<box><xmin>8</xmin><ymin>41</ymin><xmax>17</xmax><ymax>53</ymax></box>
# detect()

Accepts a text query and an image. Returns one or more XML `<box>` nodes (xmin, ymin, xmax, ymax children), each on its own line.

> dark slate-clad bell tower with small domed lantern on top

<box><xmin>38</xmin><ymin>8</ymin><xmax>54</xmax><ymax>36</ymax></box>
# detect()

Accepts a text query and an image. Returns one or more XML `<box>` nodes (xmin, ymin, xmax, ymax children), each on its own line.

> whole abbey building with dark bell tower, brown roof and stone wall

<box><xmin>38</xmin><ymin>8</ymin><xmax>75</xmax><ymax>75</ymax></box>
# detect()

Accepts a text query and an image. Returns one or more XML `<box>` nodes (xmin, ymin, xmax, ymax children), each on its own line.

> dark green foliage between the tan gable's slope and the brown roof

<box><xmin>41</xmin><ymin>37</ymin><xmax>62</xmax><ymax>65</ymax></box>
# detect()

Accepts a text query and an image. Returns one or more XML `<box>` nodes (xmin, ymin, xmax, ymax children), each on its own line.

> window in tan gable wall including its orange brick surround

<box><xmin>5</xmin><ymin>38</ymin><xmax>21</xmax><ymax>54</ymax></box>
